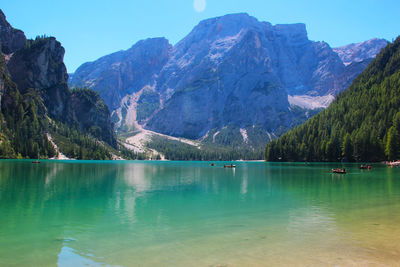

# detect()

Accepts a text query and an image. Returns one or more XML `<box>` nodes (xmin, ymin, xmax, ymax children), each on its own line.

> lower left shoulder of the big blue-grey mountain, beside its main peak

<box><xmin>70</xmin><ymin>38</ymin><xmax>171</xmax><ymax>110</ymax></box>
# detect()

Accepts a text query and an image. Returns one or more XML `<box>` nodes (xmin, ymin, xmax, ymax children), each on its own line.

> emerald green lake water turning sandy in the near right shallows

<box><xmin>0</xmin><ymin>160</ymin><xmax>400</xmax><ymax>266</ymax></box>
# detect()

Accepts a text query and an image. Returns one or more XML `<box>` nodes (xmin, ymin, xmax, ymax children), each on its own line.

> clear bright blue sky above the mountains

<box><xmin>0</xmin><ymin>0</ymin><xmax>400</xmax><ymax>72</ymax></box>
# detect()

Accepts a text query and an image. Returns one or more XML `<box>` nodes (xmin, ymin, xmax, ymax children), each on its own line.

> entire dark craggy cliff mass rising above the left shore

<box><xmin>0</xmin><ymin>8</ymin><xmax>117</xmax><ymax>157</ymax></box>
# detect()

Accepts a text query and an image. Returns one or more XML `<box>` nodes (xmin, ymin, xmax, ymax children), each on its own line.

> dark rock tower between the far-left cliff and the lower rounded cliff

<box><xmin>8</xmin><ymin>37</ymin><xmax>73</xmax><ymax>123</ymax></box>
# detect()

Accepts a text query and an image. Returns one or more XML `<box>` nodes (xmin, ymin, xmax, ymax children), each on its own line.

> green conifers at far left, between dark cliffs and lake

<box><xmin>0</xmin><ymin>53</ymin><xmax>55</xmax><ymax>158</ymax></box>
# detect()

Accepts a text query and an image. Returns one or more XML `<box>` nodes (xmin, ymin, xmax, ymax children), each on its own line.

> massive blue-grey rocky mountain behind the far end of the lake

<box><xmin>70</xmin><ymin>14</ymin><xmax>383</xmax><ymax>146</ymax></box>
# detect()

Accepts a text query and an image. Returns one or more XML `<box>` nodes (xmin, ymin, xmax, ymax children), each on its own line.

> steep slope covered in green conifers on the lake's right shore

<box><xmin>265</xmin><ymin>37</ymin><xmax>400</xmax><ymax>161</ymax></box>
